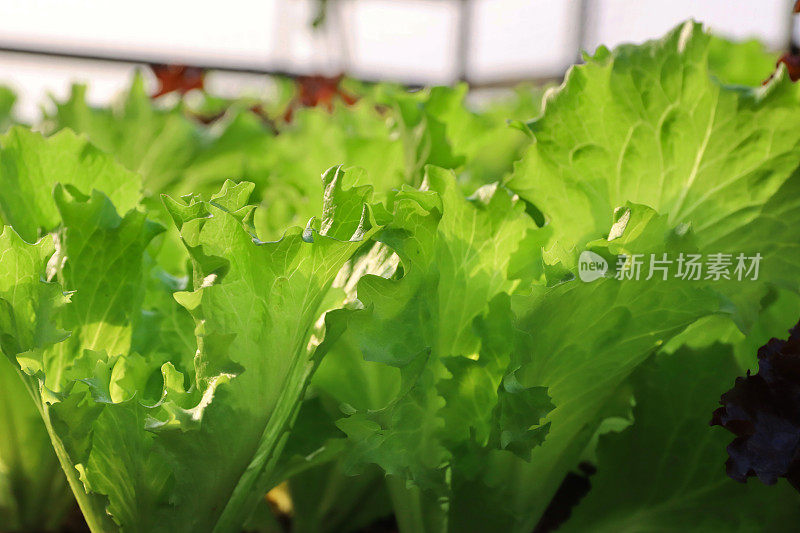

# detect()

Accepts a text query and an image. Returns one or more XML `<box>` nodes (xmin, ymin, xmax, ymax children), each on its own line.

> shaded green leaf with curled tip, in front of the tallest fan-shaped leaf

<box><xmin>444</xmin><ymin>205</ymin><xmax>724</xmax><ymax>531</ymax></box>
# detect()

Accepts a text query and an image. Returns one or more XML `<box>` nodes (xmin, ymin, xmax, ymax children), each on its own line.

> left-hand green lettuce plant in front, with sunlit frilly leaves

<box><xmin>3</xmin><ymin>123</ymin><xmax>378</xmax><ymax>531</ymax></box>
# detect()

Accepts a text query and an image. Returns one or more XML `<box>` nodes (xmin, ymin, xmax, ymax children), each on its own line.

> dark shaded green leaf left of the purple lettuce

<box><xmin>563</xmin><ymin>343</ymin><xmax>800</xmax><ymax>532</ymax></box>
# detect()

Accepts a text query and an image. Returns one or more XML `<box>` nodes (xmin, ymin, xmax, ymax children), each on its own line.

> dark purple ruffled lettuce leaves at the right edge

<box><xmin>711</xmin><ymin>324</ymin><xmax>800</xmax><ymax>491</ymax></box>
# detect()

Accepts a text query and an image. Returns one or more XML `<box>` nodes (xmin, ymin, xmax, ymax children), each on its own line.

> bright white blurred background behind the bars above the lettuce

<box><xmin>0</xmin><ymin>0</ymin><xmax>793</xmax><ymax>119</ymax></box>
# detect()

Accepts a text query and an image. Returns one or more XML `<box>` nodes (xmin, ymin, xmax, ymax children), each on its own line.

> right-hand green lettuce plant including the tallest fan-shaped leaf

<box><xmin>306</xmin><ymin>23</ymin><xmax>800</xmax><ymax>531</ymax></box>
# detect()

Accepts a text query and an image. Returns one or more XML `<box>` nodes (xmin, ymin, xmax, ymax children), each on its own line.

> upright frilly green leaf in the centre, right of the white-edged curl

<box><xmin>323</xmin><ymin>167</ymin><xmax>550</xmax><ymax>531</ymax></box>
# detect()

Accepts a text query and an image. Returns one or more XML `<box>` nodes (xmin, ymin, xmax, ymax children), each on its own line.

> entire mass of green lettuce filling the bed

<box><xmin>0</xmin><ymin>18</ymin><xmax>800</xmax><ymax>533</ymax></box>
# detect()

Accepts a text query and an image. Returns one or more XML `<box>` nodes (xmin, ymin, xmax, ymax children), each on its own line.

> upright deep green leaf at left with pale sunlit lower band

<box><xmin>43</xmin><ymin>185</ymin><xmax>163</xmax><ymax>391</ymax></box>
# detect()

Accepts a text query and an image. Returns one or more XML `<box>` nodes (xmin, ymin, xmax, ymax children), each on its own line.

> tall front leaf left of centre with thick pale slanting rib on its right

<box><xmin>156</xmin><ymin>168</ymin><xmax>377</xmax><ymax>531</ymax></box>
